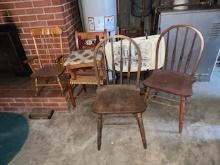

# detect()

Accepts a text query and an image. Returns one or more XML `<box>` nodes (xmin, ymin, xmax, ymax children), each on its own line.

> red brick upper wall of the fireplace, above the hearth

<box><xmin>0</xmin><ymin>0</ymin><xmax>82</xmax><ymax>69</ymax></box>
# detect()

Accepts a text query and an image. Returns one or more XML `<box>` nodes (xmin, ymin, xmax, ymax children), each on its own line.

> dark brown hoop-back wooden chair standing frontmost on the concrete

<box><xmin>92</xmin><ymin>35</ymin><xmax>147</xmax><ymax>150</ymax></box>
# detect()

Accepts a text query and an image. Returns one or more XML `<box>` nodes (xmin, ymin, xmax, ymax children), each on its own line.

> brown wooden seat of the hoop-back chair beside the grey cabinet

<box><xmin>143</xmin><ymin>70</ymin><xmax>195</xmax><ymax>97</ymax></box>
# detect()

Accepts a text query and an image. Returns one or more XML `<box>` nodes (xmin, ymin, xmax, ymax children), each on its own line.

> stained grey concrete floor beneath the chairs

<box><xmin>10</xmin><ymin>67</ymin><xmax>220</xmax><ymax>165</ymax></box>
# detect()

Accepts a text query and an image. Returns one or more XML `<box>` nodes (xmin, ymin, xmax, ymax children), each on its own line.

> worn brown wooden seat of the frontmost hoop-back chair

<box><xmin>93</xmin><ymin>85</ymin><xmax>145</xmax><ymax>114</ymax></box>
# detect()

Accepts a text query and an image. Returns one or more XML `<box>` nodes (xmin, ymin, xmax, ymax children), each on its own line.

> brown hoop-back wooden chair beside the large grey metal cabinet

<box><xmin>143</xmin><ymin>25</ymin><xmax>204</xmax><ymax>133</ymax></box>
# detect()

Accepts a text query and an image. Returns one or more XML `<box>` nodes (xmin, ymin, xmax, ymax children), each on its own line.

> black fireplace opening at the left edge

<box><xmin>0</xmin><ymin>23</ymin><xmax>31</xmax><ymax>77</ymax></box>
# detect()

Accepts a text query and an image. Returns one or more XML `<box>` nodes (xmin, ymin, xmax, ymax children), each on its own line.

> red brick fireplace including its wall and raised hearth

<box><xmin>0</xmin><ymin>0</ymin><xmax>82</xmax><ymax>111</ymax></box>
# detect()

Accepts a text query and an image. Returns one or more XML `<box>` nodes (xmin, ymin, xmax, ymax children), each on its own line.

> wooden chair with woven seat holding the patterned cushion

<box><xmin>67</xmin><ymin>31</ymin><xmax>107</xmax><ymax>106</ymax></box>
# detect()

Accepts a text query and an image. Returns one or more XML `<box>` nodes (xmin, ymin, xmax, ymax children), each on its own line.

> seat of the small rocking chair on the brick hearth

<box><xmin>31</xmin><ymin>64</ymin><xmax>65</xmax><ymax>78</ymax></box>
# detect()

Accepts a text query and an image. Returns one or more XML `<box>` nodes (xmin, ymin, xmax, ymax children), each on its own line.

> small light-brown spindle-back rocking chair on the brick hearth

<box><xmin>27</xmin><ymin>27</ymin><xmax>65</xmax><ymax>96</ymax></box>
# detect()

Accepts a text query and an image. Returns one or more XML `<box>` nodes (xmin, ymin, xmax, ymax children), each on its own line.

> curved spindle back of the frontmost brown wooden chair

<box><xmin>94</xmin><ymin>35</ymin><xmax>141</xmax><ymax>87</ymax></box>
